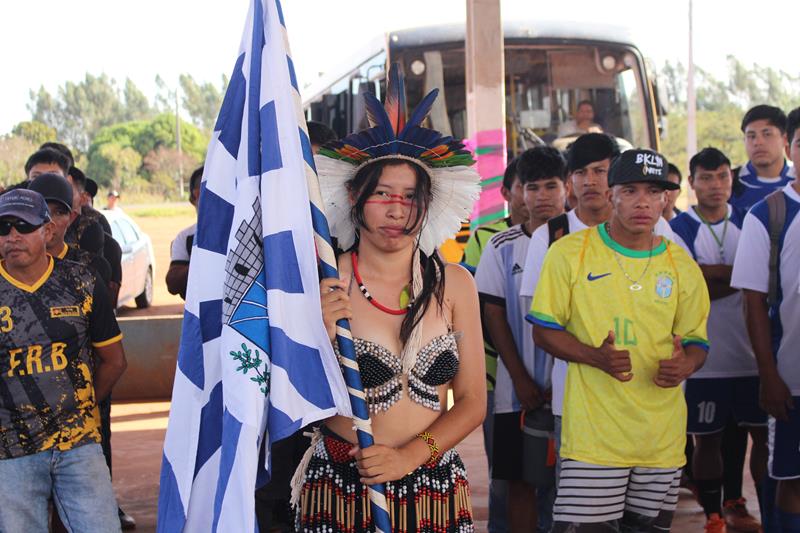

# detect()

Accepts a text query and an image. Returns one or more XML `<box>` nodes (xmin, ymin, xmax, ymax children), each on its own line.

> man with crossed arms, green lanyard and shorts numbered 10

<box><xmin>670</xmin><ymin>148</ymin><xmax>767</xmax><ymax>531</ymax></box>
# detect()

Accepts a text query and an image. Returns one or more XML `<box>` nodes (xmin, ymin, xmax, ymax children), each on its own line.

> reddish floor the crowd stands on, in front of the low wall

<box><xmin>112</xmin><ymin>402</ymin><xmax>756</xmax><ymax>533</ymax></box>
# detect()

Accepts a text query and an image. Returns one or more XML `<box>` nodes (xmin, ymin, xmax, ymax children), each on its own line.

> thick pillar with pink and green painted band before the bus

<box><xmin>465</xmin><ymin>0</ymin><xmax>506</xmax><ymax>229</ymax></box>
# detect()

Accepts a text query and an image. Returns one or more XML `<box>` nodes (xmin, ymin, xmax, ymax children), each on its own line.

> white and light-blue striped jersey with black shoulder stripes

<box><xmin>475</xmin><ymin>225</ymin><xmax>552</xmax><ymax>413</ymax></box>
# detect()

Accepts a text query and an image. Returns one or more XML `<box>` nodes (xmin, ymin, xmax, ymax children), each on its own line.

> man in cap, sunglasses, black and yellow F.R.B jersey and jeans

<box><xmin>0</xmin><ymin>190</ymin><xmax>126</xmax><ymax>533</ymax></box>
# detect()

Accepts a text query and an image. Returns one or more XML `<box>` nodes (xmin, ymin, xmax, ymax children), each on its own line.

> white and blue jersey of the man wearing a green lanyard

<box><xmin>670</xmin><ymin>205</ymin><xmax>758</xmax><ymax>378</ymax></box>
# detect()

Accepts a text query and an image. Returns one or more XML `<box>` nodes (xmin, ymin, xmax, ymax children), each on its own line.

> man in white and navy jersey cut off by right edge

<box><xmin>731</xmin><ymin>108</ymin><xmax>800</xmax><ymax>532</ymax></box>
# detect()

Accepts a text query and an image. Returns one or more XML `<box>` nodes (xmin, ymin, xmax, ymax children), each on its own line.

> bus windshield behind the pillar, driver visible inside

<box><xmin>391</xmin><ymin>43</ymin><xmax>652</xmax><ymax>155</ymax></box>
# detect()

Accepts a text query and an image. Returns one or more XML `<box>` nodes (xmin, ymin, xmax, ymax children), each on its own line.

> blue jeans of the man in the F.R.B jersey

<box><xmin>0</xmin><ymin>444</ymin><xmax>120</xmax><ymax>533</ymax></box>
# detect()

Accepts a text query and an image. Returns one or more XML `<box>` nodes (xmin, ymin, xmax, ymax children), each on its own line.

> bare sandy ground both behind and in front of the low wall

<box><xmin>112</xmin><ymin>210</ymin><xmax>758</xmax><ymax>533</ymax></box>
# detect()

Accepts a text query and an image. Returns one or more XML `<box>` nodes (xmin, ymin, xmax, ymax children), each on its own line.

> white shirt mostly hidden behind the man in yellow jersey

<box><xmin>520</xmin><ymin>209</ymin><xmax>673</xmax><ymax>416</ymax></box>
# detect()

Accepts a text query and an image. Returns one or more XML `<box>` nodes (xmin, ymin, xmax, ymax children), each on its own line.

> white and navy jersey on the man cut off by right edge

<box><xmin>731</xmin><ymin>184</ymin><xmax>800</xmax><ymax>396</ymax></box>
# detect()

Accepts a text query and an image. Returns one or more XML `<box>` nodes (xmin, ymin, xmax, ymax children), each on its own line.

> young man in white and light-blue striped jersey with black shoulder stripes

<box><xmin>475</xmin><ymin>146</ymin><xmax>566</xmax><ymax>532</ymax></box>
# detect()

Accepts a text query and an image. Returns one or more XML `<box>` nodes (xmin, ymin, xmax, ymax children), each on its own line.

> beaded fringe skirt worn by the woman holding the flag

<box><xmin>296</xmin><ymin>435</ymin><xmax>475</xmax><ymax>533</ymax></box>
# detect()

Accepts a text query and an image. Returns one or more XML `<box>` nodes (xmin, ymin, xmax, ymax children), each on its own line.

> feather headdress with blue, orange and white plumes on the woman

<box><xmin>315</xmin><ymin>63</ymin><xmax>480</xmax><ymax>255</ymax></box>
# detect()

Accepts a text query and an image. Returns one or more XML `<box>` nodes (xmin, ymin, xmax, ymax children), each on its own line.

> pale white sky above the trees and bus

<box><xmin>0</xmin><ymin>0</ymin><xmax>800</xmax><ymax>134</ymax></box>
